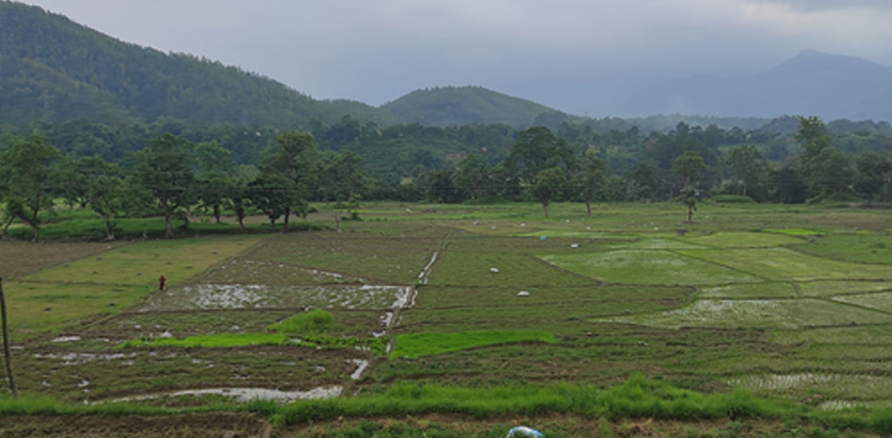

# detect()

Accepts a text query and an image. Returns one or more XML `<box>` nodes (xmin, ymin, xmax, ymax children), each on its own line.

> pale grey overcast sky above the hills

<box><xmin>17</xmin><ymin>0</ymin><xmax>892</xmax><ymax>116</ymax></box>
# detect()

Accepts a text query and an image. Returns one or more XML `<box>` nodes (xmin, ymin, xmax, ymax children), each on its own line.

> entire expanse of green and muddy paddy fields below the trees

<box><xmin>0</xmin><ymin>203</ymin><xmax>892</xmax><ymax>437</ymax></box>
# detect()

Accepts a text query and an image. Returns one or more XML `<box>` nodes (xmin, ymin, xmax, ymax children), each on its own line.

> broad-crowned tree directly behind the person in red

<box><xmin>133</xmin><ymin>134</ymin><xmax>195</xmax><ymax>238</ymax></box>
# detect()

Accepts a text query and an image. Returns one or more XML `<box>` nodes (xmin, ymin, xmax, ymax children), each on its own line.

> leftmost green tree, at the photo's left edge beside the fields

<box><xmin>0</xmin><ymin>135</ymin><xmax>63</xmax><ymax>242</ymax></box>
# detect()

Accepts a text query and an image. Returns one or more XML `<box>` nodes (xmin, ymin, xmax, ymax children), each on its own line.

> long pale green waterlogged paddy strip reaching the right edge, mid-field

<box><xmin>598</xmin><ymin>299</ymin><xmax>892</xmax><ymax>329</ymax></box>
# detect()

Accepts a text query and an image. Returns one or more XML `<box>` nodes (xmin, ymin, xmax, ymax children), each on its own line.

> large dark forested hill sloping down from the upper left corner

<box><xmin>0</xmin><ymin>1</ymin><xmax>395</xmax><ymax>127</ymax></box>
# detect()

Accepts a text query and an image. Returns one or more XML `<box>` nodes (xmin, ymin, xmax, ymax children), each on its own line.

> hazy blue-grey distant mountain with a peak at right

<box><xmin>620</xmin><ymin>50</ymin><xmax>892</xmax><ymax>121</ymax></box>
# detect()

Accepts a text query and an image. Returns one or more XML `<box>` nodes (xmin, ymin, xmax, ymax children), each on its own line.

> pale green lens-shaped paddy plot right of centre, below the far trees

<box><xmin>542</xmin><ymin>250</ymin><xmax>760</xmax><ymax>285</ymax></box>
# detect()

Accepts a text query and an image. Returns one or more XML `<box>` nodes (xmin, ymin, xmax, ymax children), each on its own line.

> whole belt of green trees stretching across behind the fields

<box><xmin>0</xmin><ymin>117</ymin><xmax>892</xmax><ymax>240</ymax></box>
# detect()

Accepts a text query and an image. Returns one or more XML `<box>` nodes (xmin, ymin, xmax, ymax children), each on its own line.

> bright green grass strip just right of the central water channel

<box><xmin>390</xmin><ymin>331</ymin><xmax>555</xmax><ymax>358</ymax></box>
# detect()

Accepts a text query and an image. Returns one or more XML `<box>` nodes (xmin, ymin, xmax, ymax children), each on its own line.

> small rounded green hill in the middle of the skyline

<box><xmin>381</xmin><ymin>87</ymin><xmax>572</xmax><ymax>127</ymax></box>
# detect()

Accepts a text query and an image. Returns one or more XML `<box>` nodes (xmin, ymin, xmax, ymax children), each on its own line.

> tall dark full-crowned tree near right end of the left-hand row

<box><xmin>260</xmin><ymin>131</ymin><xmax>316</xmax><ymax>231</ymax></box>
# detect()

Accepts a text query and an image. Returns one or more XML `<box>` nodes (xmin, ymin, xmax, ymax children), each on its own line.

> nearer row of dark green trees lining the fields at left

<box><xmin>0</xmin><ymin>131</ymin><xmax>366</xmax><ymax>241</ymax></box>
